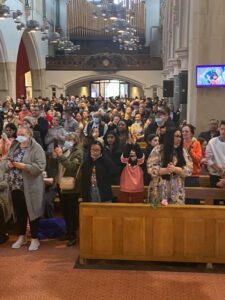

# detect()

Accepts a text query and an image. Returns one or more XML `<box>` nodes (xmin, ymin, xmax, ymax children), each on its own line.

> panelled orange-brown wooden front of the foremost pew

<box><xmin>80</xmin><ymin>202</ymin><xmax>225</xmax><ymax>263</ymax></box>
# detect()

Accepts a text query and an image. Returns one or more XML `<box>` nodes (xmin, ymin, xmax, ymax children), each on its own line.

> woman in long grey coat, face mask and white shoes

<box><xmin>1</xmin><ymin>127</ymin><xmax>46</xmax><ymax>251</ymax></box>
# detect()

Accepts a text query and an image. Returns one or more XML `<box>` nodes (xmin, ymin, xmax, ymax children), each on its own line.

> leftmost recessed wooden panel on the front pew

<box><xmin>93</xmin><ymin>217</ymin><xmax>112</xmax><ymax>254</ymax></box>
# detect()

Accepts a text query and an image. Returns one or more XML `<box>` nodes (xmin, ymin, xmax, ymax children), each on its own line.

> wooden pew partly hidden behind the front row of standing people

<box><xmin>112</xmin><ymin>185</ymin><xmax>225</xmax><ymax>205</ymax></box>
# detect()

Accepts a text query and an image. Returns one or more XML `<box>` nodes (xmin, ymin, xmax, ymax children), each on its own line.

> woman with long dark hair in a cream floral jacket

<box><xmin>147</xmin><ymin>128</ymin><xmax>193</xmax><ymax>204</ymax></box>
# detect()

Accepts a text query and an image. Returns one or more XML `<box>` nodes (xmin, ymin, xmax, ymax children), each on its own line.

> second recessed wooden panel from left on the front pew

<box><xmin>123</xmin><ymin>217</ymin><xmax>146</xmax><ymax>255</ymax></box>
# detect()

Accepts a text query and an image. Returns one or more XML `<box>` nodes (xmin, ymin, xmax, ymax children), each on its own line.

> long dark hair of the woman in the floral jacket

<box><xmin>162</xmin><ymin>128</ymin><xmax>186</xmax><ymax>180</ymax></box>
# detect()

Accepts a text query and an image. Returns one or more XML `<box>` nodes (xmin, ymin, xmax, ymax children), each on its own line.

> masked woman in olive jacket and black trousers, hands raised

<box><xmin>54</xmin><ymin>133</ymin><xmax>83</xmax><ymax>246</ymax></box>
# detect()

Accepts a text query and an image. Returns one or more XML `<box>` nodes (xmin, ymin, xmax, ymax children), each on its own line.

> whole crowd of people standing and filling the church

<box><xmin>0</xmin><ymin>96</ymin><xmax>225</xmax><ymax>251</ymax></box>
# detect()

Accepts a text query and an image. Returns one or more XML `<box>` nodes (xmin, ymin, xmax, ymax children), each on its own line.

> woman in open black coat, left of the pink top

<box><xmin>82</xmin><ymin>141</ymin><xmax>117</xmax><ymax>202</ymax></box>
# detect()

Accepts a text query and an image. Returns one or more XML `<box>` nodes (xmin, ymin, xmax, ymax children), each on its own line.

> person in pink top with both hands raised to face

<box><xmin>118</xmin><ymin>137</ymin><xmax>145</xmax><ymax>203</ymax></box>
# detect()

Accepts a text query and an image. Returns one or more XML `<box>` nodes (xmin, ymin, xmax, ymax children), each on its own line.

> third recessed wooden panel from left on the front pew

<box><xmin>153</xmin><ymin>218</ymin><xmax>174</xmax><ymax>257</ymax></box>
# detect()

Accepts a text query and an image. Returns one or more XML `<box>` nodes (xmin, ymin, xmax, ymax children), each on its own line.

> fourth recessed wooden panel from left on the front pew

<box><xmin>184</xmin><ymin>219</ymin><xmax>205</xmax><ymax>257</ymax></box>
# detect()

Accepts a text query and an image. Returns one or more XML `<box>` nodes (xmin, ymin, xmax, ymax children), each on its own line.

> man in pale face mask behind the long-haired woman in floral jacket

<box><xmin>145</xmin><ymin>106</ymin><xmax>175</xmax><ymax>142</ymax></box>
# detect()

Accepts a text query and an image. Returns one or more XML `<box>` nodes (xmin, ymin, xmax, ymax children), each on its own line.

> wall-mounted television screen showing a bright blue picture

<box><xmin>196</xmin><ymin>65</ymin><xmax>225</xmax><ymax>87</ymax></box>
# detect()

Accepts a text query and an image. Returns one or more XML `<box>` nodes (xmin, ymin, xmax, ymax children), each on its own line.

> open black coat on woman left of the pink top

<box><xmin>82</xmin><ymin>154</ymin><xmax>117</xmax><ymax>202</ymax></box>
